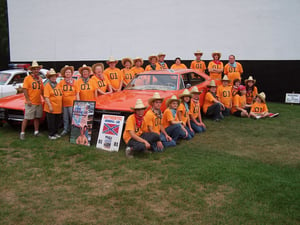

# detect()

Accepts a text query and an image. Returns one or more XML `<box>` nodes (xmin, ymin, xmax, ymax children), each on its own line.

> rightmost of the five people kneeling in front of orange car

<box><xmin>189</xmin><ymin>86</ymin><xmax>206</xmax><ymax>133</ymax></box>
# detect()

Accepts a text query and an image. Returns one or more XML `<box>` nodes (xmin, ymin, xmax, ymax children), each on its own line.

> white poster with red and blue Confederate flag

<box><xmin>96</xmin><ymin>114</ymin><xmax>124</xmax><ymax>152</ymax></box>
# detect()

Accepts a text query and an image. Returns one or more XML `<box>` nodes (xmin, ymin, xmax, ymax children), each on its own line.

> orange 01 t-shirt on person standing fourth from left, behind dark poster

<box><xmin>75</xmin><ymin>78</ymin><xmax>96</xmax><ymax>101</ymax></box>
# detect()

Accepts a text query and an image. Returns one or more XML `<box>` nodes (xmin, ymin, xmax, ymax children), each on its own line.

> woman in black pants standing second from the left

<box><xmin>44</xmin><ymin>68</ymin><xmax>62</xmax><ymax>140</ymax></box>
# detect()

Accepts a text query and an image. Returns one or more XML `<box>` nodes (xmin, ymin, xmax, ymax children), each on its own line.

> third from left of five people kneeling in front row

<box><xmin>162</xmin><ymin>95</ymin><xmax>188</xmax><ymax>143</ymax></box>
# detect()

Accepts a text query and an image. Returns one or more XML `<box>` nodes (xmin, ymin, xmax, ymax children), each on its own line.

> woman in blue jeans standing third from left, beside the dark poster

<box><xmin>58</xmin><ymin>65</ymin><xmax>76</xmax><ymax>136</ymax></box>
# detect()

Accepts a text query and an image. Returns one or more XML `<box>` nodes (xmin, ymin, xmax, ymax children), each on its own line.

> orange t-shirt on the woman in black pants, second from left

<box><xmin>44</xmin><ymin>83</ymin><xmax>63</xmax><ymax>114</ymax></box>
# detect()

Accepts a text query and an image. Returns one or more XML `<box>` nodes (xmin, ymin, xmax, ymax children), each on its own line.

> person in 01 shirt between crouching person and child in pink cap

<box><xmin>217</xmin><ymin>75</ymin><xmax>232</xmax><ymax>116</ymax></box>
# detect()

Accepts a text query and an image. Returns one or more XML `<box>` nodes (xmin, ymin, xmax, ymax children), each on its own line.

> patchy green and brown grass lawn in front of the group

<box><xmin>0</xmin><ymin>103</ymin><xmax>300</xmax><ymax>225</ymax></box>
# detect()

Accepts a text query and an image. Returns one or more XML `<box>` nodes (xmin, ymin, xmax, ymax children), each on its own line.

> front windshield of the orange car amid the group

<box><xmin>126</xmin><ymin>74</ymin><xmax>178</xmax><ymax>90</ymax></box>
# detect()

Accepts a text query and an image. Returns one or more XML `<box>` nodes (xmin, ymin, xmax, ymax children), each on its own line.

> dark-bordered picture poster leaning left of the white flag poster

<box><xmin>70</xmin><ymin>101</ymin><xmax>96</xmax><ymax>146</ymax></box>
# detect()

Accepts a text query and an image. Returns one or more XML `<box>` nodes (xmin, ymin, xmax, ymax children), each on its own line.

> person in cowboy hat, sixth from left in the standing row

<box><xmin>104</xmin><ymin>57</ymin><xmax>123</xmax><ymax>92</ymax></box>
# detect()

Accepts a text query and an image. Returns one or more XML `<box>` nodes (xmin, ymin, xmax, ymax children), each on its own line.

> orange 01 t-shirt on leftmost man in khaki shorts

<box><xmin>23</xmin><ymin>75</ymin><xmax>44</xmax><ymax>105</ymax></box>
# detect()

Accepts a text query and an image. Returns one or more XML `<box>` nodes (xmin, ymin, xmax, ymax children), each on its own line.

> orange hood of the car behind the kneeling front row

<box><xmin>96</xmin><ymin>90</ymin><xmax>178</xmax><ymax>112</ymax></box>
